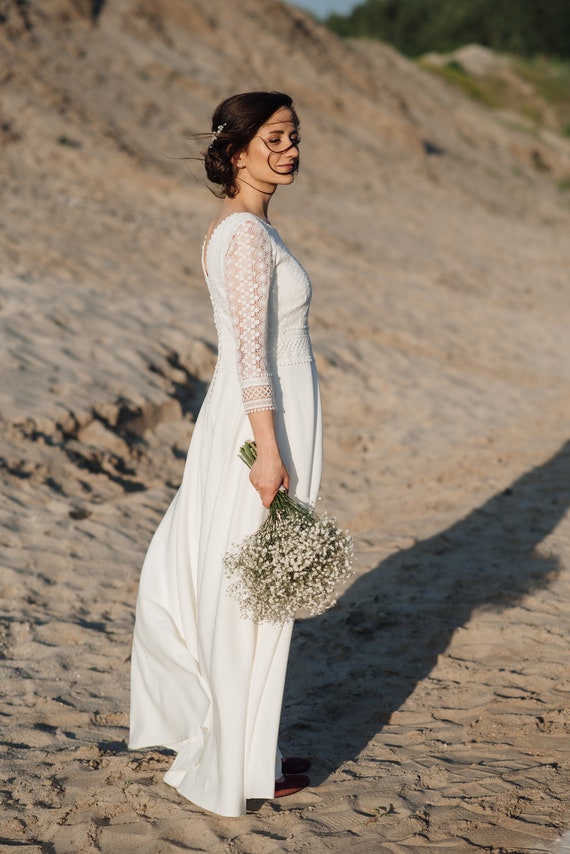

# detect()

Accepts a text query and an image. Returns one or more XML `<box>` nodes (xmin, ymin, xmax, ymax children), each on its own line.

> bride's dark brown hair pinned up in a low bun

<box><xmin>204</xmin><ymin>92</ymin><xmax>299</xmax><ymax>199</ymax></box>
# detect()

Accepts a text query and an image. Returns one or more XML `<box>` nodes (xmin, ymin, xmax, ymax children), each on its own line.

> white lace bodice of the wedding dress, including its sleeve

<box><xmin>203</xmin><ymin>213</ymin><xmax>313</xmax><ymax>412</ymax></box>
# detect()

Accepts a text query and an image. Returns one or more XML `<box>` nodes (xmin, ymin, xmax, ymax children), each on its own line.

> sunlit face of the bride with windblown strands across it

<box><xmin>236</xmin><ymin>107</ymin><xmax>300</xmax><ymax>192</ymax></box>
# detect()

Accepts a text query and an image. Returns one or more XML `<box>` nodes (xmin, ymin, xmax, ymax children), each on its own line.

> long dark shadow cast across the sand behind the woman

<box><xmin>281</xmin><ymin>442</ymin><xmax>570</xmax><ymax>783</ymax></box>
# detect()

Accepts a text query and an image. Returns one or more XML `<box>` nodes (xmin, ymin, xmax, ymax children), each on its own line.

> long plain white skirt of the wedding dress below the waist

<box><xmin>129</xmin><ymin>361</ymin><xmax>322</xmax><ymax>816</ymax></box>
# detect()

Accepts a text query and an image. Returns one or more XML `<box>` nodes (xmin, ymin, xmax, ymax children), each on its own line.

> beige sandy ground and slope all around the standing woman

<box><xmin>0</xmin><ymin>0</ymin><xmax>570</xmax><ymax>854</ymax></box>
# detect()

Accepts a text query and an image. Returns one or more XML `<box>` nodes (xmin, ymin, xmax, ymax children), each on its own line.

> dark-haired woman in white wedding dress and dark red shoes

<box><xmin>129</xmin><ymin>92</ymin><xmax>322</xmax><ymax>816</ymax></box>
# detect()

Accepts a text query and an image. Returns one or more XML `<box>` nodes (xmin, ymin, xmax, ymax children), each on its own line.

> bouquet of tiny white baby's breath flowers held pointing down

<box><xmin>224</xmin><ymin>441</ymin><xmax>353</xmax><ymax>624</ymax></box>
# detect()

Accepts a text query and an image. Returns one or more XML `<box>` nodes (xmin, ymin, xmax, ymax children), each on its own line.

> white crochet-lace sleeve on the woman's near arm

<box><xmin>225</xmin><ymin>219</ymin><xmax>275</xmax><ymax>412</ymax></box>
